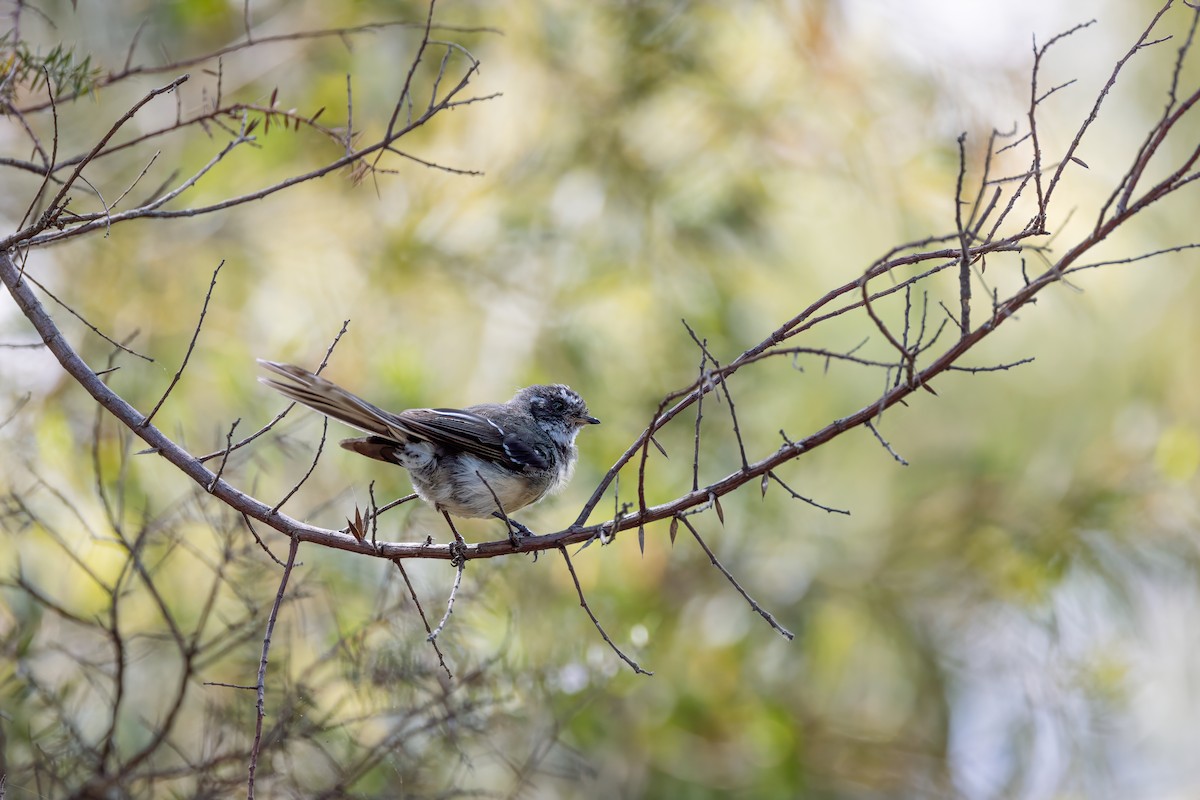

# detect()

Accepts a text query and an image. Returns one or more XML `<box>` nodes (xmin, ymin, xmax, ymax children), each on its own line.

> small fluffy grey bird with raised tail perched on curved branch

<box><xmin>258</xmin><ymin>359</ymin><xmax>600</xmax><ymax>534</ymax></box>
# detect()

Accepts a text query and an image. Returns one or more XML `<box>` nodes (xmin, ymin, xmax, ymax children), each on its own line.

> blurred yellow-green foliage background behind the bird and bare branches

<box><xmin>0</xmin><ymin>0</ymin><xmax>1200</xmax><ymax>799</ymax></box>
